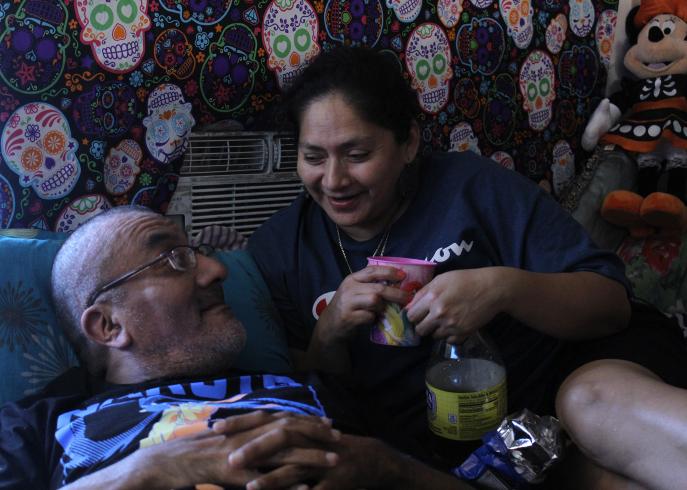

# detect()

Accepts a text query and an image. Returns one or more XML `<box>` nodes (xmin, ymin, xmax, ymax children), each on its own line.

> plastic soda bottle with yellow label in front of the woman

<box><xmin>425</xmin><ymin>332</ymin><xmax>507</xmax><ymax>452</ymax></box>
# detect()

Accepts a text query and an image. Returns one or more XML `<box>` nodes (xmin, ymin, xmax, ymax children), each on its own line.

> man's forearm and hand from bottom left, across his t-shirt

<box><xmin>63</xmin><ymin>412</ymin><xmax>340</xmax><ymax>490</ymax></box>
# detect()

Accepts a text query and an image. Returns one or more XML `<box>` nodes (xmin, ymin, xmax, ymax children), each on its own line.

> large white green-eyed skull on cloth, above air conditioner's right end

<box><xmin>262</xmin><ymin>0</ymin><xmax>320</xmax><ymax>90</ymax></box>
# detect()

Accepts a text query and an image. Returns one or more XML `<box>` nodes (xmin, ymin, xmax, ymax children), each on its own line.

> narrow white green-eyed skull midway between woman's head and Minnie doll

<box><xmin>519</xmin><ymin>49</ymin><xmax>556</xmax><ymax>131</ymax></box>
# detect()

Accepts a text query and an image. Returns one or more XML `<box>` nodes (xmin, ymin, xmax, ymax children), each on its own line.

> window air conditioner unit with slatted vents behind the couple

<box><xmin>167</xmin><ymin>131</ymin><xmax>302</xmax><ymax>237</ymax></box>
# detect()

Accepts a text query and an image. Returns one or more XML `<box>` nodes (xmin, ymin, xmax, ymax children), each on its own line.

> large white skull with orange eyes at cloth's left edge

<box><xmin>0</xmin><ymin>102</ymin><xmax>81</xmax><ymax>199</ymax></box>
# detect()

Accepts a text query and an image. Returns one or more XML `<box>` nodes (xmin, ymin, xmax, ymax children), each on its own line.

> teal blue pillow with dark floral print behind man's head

<box><xmin>0</xmin><ymin>229</ymin><xmax>292</xmax><ymax>404</ymax></box>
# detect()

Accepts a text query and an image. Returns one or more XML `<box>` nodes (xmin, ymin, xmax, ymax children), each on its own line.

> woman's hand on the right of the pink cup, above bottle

<box><xmin>406</xmin><ymin>267</ymin><xmax>504</xmax><ymax>343</ymax></box>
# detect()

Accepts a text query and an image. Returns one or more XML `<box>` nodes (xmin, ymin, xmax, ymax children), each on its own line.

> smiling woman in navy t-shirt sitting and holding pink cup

<box><xmin>249</xmin><ymin>48</ymin><xmax>687</xmax><ymax>489</ymax></box>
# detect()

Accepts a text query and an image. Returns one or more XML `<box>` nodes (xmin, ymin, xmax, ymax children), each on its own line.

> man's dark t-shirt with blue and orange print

<box><xmin>0</xmin><ymin>368</ymin><xmax>357</xmax><ymax>490</ymax></box>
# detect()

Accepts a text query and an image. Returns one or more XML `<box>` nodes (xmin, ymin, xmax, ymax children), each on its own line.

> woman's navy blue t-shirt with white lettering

<box><xmin>249</xmin><ymin>152</ymin><xmax>626</xmax><ymax>456</ymax></box>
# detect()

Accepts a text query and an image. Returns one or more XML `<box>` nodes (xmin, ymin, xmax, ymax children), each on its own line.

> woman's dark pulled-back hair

<box><xmin>283</xmin><ymin>46</ymin><xmax>420</xmax><ymax>143</ymax></box>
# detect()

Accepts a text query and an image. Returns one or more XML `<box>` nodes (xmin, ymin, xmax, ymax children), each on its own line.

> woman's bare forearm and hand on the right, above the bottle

<box><xmin>408</xmin><ymin>267</ymin><xmax>630</xmax><ymax>342</ymax></box>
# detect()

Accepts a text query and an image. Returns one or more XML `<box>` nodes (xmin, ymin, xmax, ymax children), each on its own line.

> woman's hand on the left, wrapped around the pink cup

<box><xmin>316</xmin><ymin>266</ymin><xmax>410</xmax><ymax>345</ymax></box>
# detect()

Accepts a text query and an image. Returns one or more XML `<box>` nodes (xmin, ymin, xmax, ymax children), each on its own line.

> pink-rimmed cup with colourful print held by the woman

<box><xmin>367</xmin><ymin>257</ymin><xmax>436</xmax><ymax>347</ymax></box>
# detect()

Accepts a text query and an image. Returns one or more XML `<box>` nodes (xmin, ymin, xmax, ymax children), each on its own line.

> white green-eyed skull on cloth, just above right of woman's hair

<box><xmin>406</xmin><ymin>22</ymin><xmax>453</xmax><ymax>114</ymax></box>
